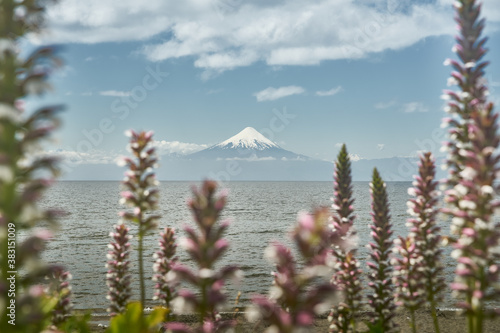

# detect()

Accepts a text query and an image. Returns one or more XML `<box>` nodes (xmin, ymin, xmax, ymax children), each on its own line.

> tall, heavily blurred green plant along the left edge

<box><xmin>0</xmin><ymin>0</ymin><xmax>75</xmax><ymax>333</ymax></box>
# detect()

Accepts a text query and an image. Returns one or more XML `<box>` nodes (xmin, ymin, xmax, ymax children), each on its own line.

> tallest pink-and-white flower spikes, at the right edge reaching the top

<box><xmin>443</xmin><ymin>0</ymin><xmax>500</xmax><ymax>333</ymax></box>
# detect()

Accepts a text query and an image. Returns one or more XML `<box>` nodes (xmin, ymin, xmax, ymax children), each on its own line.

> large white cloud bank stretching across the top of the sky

<box><xmin>32</xmin><ymin>0</ymin><xmax>500</xmax><ymax>72</ymax></box>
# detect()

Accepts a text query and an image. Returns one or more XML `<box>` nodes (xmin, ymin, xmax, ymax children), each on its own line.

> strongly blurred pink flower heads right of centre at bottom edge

<box><xmin>247</xmin><ymin>208</ymin><xmax>342</xmax><ymax>333</ymax></box>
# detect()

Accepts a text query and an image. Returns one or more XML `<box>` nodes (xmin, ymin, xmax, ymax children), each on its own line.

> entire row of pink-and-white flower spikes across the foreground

<box><xmin>0</xmin><ymin>0</ymin><xmax>500</xmax><ymax>333</ymax></box>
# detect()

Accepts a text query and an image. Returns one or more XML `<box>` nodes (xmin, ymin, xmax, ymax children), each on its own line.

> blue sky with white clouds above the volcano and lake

<box><xmin>23</xmin><ymin>0</ymin><xmax>500</xmax><ymax>176</ymax></box>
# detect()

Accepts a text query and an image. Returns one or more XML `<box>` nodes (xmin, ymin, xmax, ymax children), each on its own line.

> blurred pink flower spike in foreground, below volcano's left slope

<box><xmin>165</xmin><ymin>181</ymin><xmax>241</xmax><ymax>333</ymax></box>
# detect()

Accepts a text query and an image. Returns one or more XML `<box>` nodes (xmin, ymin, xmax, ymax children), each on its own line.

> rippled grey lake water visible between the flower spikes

<box><xmin>38</xmin><ymin>182</ymin><xmax>468</xmax><ymax>312</ymax></box>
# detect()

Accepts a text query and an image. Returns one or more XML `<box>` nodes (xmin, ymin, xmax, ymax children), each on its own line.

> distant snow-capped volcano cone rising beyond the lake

<box><xmin>188</xmin><ymin>127</ymin><xmax>310</xmax><ymax>161</ymax></box>
